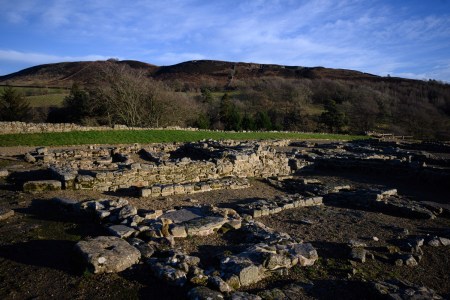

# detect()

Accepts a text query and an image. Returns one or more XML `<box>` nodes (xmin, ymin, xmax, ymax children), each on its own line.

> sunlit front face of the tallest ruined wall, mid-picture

<box><xmin>64</xmin><ymin>151</ymin><xmax>291</xmax><ymax>191</ymax></box>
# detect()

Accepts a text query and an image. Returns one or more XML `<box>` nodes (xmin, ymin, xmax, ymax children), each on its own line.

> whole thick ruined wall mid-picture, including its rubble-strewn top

<box><xmin>36</xmin><ymin>142</ymin><xmax>292</xmax><ymax>195</ymax></box>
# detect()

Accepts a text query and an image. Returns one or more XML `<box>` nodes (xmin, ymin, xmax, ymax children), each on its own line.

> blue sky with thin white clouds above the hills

<box><xmin>0</xmin><ymin>0</ymin><xmax>450</xmax><ymax>82</ymax></box>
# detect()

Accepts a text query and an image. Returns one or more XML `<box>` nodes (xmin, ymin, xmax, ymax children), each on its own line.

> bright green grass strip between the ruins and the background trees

<box><xmin>0</xmin><ymin>130</ymin><xmax>368</xmax><ymax>147</ymax></box>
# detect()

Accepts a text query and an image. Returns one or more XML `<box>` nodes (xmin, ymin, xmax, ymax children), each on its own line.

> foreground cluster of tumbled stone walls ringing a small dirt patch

<box><xmin>61</xmin><ymin>198</ymin><xmax>318</xmax><ymax>292</ymax></box>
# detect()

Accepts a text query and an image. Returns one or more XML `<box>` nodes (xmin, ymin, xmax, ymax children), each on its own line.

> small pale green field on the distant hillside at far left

<box><xmin>0</xmin><ymin>86</ymin><xmax>69</xmax><ymax>107</ymax></box>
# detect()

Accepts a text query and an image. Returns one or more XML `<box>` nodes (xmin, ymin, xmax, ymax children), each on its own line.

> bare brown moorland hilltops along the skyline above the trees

<box><xmin>0</xmin><ymin>60</ymin><xmax>386</xmax><ymax>87</ymax></box>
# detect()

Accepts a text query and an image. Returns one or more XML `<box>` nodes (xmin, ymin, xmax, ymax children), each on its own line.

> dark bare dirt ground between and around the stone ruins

<box><xmin>0</xmin><ymin>145</ymin><xmax>450</xmax><ymax>299</ymax></box>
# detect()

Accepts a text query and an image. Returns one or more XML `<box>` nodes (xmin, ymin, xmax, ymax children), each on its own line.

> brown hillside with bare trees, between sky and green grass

<box><xmin>0</xmin><ymin>59</ymin><xmax>450</xmax><ymax>140</ymax></box>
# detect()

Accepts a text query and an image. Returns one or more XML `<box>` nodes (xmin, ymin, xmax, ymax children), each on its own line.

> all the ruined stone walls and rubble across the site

<box><xmin>0</xmin><ymin>140</ymin><xmax>450</xmax><ymax>299</ymax></box>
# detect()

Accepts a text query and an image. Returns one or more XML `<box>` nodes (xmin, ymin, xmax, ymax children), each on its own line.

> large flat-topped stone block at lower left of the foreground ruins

<box><xmin>75</xmin><ymin>236</ymin><xmax>141</xmax><ymax>274</ymax></box>
